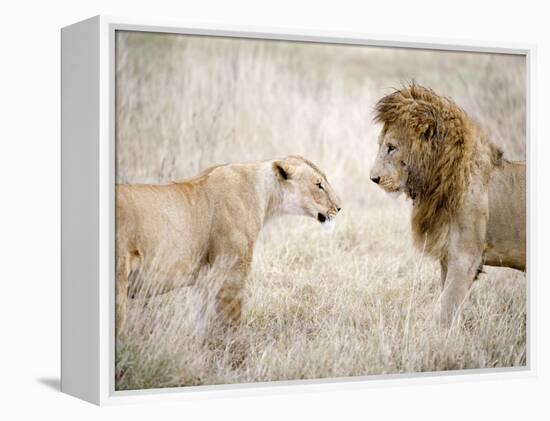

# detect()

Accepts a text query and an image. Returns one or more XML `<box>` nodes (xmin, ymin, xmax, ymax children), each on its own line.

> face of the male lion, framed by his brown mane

<box><xmin>370</xmin><ymin>131</ymin><xmax>408</xmax><ymax>194</ymax></box>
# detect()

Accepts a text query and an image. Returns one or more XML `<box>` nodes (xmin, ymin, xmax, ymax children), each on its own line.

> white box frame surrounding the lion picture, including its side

<box><xmin>61</xmin><ymin>16</ymin><xmax>536</xmax><ymax>405</ymax></box>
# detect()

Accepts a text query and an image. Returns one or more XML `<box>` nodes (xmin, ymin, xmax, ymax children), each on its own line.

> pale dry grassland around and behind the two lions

<box><xmin>116</xmin><ymin>32</ymin><xmax>527</xmax><ymax>389</ymax></box>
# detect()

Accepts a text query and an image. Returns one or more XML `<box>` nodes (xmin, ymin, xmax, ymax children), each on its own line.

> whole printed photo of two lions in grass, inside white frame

<box><xmin>114</xmin><ymin>31</ymin><xmax>528</xmax><ymax>390</ymax></box>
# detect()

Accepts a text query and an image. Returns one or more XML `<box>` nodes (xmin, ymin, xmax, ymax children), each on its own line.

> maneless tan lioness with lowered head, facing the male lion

<box><xmin>116</xmin><ymin>156</ymin><xmax>340</xmax><ymax>332</ymax></box>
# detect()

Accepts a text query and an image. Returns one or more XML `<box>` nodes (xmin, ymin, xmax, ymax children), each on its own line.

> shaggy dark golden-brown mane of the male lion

<box><xmin>375</xmin><ymin>83</ymin><xmax>502</xmax><ymax>258</ymax></box>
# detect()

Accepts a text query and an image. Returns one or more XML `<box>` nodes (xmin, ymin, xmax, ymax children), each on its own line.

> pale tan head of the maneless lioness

<box><xmin>273</xmin><ymin>156</ymin><xmax>341</xmax><ymax>223</ymax></box>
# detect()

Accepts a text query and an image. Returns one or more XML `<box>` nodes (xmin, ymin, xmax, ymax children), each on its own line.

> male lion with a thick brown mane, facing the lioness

<box><xmin>370</xmin><ymin>84</ymin><xmax>526</xmax><ymax>325</ymax></box>
